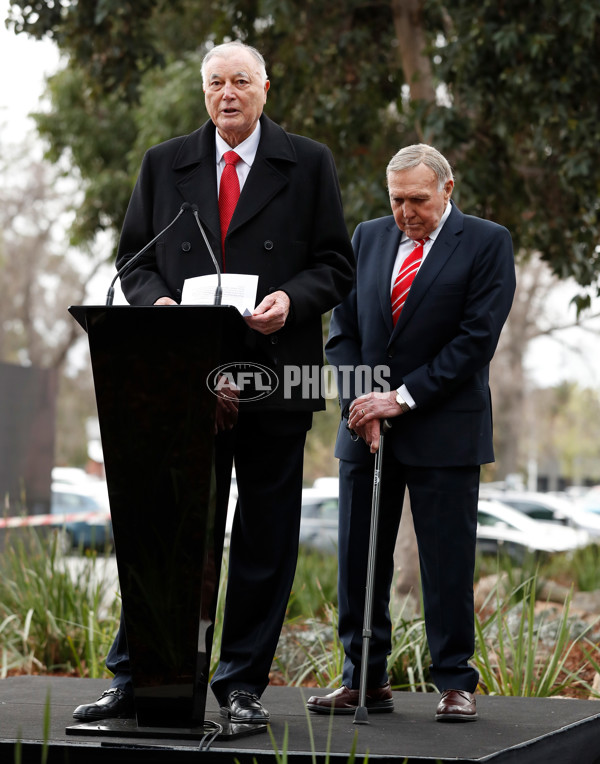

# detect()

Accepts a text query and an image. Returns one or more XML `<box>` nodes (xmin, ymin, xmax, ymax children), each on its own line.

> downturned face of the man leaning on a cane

<box><xmin>388</xmin><ymin>164</ymin><xmax>454</xmax><ymax>239</ymax></box>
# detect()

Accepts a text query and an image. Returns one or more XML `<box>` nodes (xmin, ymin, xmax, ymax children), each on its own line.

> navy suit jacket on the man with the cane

<box><xmin>326</xmin><ymin>204</ymin><xmax>515</xmax><ymax>467</ymax></box>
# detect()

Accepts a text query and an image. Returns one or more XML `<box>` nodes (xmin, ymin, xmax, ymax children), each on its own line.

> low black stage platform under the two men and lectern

<box><xmin>0</xmin><ymin>677</ymin><xmax>600</xmax><ymax>764</ymax></box>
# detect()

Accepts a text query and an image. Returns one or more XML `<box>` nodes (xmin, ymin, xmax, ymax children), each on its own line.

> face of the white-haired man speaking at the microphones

<box><xmin>204</xmin><ymin>50</ymin><xmax>269</xmax><ymax>148</ymax></box>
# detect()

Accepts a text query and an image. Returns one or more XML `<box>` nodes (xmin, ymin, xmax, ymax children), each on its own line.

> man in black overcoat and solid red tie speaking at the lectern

<box><xmin>74</xmin><ymin>42</ymin><xmax>354</xmax><ymax>724</ymax></box>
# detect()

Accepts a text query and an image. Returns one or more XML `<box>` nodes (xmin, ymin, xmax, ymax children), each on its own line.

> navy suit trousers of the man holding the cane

<box><xmin>338</xmin><ymin>448</ymin><xmax>479</xmax><ymax>692</ymax></box>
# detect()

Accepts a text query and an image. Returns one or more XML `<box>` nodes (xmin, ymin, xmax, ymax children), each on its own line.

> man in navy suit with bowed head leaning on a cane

<box><xmin>307</xmin><ymin>144</ymin><xmax>515</xmax><ymax>722</ymax></box>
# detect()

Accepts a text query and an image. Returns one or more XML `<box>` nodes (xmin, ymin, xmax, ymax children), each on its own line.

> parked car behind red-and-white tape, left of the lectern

<box><xmin>50</xmin><ymin>480</ymin><xmax>113</xmax><ymax>554</ymax></box>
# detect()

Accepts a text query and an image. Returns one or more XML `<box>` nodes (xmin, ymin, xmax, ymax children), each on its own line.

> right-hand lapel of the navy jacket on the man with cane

<box><xmin>392</xmin><ymin>203</ymin><xmax>464</xmax><ymax>339</ymax></box>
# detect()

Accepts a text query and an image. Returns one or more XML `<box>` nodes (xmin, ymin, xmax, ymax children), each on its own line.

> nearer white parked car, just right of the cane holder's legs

<box><xmin>477</xmin><ymin>499</ymin><xmax>590</xmax><ymax>564</ymax></box>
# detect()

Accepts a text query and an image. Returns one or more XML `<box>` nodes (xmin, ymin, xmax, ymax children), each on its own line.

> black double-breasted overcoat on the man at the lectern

<box><xmin>117</xmin><ymin>114</ymin><xmax>354</xmax><ymax>411</ymax></box>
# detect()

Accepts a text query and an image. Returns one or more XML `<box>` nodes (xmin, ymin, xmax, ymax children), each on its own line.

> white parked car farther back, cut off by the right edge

<box><xmin>480</xmin><ymin>485</ymin><xmax>600</xmax><ymax>541</ymax></box>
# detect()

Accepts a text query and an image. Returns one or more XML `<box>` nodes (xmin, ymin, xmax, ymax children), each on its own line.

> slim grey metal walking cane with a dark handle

<box><xmin>353</xmin><ymin>419</ymin><xmax>391</xmax><ymax>724</ymax></box>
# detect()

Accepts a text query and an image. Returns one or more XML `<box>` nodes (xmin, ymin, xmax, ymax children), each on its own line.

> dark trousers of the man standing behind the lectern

<box><xmin>106</xmin><ymin>403</ymin><xmax>312</xmax><ymax>704</ymax></box>
